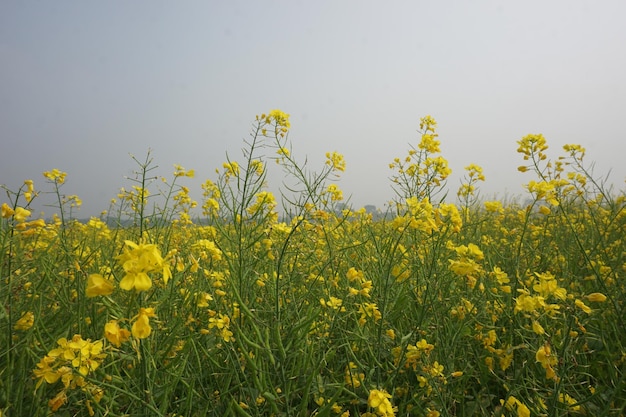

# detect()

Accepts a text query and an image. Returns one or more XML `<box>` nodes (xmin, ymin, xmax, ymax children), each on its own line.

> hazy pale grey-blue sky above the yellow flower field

<box><xmin>0</xmin><ymin>0</ymin><xmax>626</xmax><ymax>217</ymax></box>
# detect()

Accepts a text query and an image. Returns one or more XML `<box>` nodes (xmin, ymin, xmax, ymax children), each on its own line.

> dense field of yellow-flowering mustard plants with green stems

<box><xmin>0</xmin><ymin>110</ymin><xmax>626</xmax><ymax>417</ymax></box>
